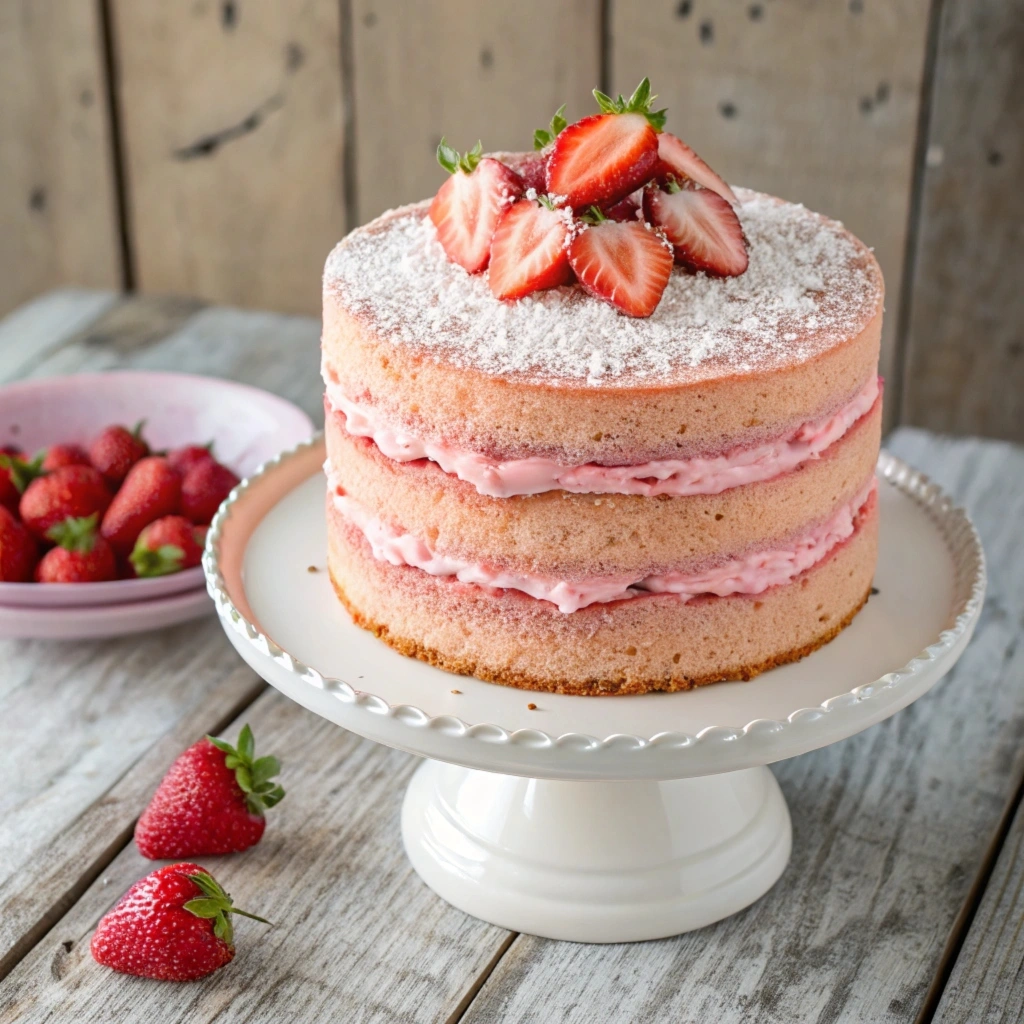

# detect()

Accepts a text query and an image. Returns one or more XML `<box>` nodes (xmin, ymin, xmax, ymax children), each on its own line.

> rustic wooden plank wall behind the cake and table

<box><xmin>0</xmin><ymin>0</ymin><xmax>1024</xmax><ymax>439</ymax></box>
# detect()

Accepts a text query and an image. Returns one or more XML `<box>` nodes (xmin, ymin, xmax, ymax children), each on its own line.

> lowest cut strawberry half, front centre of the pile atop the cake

<box><xmin>569</xmin><ymin>209</ymin><xmax>672</xmax><ymax>316</ymax></box>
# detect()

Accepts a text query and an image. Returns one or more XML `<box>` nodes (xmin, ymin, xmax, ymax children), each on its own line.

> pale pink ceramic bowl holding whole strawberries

<box><xmin>0</xmin><ymin>371</ymin><xmax>313</xmax><ymax>618</ymax></box>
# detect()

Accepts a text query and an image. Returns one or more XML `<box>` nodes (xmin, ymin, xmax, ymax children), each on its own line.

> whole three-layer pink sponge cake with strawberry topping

<box><xmin>323</xmin><ymin>81</ymin><xmax>883</xmax><ymax>694</ymax></box>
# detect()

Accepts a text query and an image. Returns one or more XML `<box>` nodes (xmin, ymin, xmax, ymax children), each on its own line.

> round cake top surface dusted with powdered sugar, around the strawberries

<box><xmin>324</xmin><ymin>188</ymin><xmax>883</xmax><ymax>387</ymax></box>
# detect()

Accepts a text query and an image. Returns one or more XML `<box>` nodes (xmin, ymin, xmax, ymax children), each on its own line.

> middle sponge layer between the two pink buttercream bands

<box><xmin>327</xmin><ymin>402</ymin><xmax>881</xmax><ymax>581</ymax></box>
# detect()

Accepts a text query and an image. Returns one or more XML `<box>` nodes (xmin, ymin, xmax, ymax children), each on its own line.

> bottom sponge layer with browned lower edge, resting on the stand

<box><xmin>329</xmin><ymin>489</ymin><xmax>878</xmax><ymax>694</ymax></box>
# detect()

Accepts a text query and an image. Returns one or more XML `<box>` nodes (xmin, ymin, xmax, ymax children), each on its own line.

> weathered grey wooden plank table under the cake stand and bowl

<box><xmin>0</xmin><ymin>292</ymin><xmax>1024</xmax><ymax>1024</ymax></box>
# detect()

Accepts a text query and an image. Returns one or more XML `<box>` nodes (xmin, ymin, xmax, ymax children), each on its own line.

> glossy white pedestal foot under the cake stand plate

<box><xmin>401</xmin><ymin>761</ymin><xmax>793</xmax><ymax>942</ymax></box>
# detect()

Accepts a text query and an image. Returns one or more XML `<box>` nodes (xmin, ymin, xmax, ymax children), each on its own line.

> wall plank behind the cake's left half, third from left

<box><xmin>351</xmin><ymin>0</ymin><xmax>601</xmax><ymax>222</ymax></box>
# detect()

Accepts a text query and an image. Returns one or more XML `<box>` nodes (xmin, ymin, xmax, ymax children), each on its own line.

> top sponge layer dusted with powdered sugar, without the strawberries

<box><xmin>323</xmin><ymin>191</ymin><xmax>883</xmax><ymax>466</ymax></box>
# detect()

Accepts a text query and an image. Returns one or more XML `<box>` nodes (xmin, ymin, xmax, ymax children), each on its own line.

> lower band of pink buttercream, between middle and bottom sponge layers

<box><xmin>325</xmin><ymin>467</ymin><xmax>878</xmax><ymax>612</ymax></box>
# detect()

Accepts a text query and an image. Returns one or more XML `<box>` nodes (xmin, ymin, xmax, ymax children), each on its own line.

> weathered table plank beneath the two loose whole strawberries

<box><xmin>0</xmin><ymin>692</ymin><xmax>507</xmax><ymax>1024</ymax></box>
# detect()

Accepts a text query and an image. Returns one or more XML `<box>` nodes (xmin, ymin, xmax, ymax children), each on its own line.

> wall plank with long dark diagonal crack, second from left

<box><xmin>112</xmin><ymin>0</ymin><xmax>345</xmax><ymax>313</ymax></box>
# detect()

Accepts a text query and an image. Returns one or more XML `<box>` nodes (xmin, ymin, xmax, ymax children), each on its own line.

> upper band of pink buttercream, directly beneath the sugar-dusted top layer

<box><xmin>324</xmin><ymin>368</ymin><xmax>880</xmax><ymax>498</ymax></box>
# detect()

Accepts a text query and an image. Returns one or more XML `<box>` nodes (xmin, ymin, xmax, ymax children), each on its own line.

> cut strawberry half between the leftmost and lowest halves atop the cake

<box><xmin>487</xmin><ymin>199</ymin><xmax>572</xmax><ymax>299</ymax></box>
